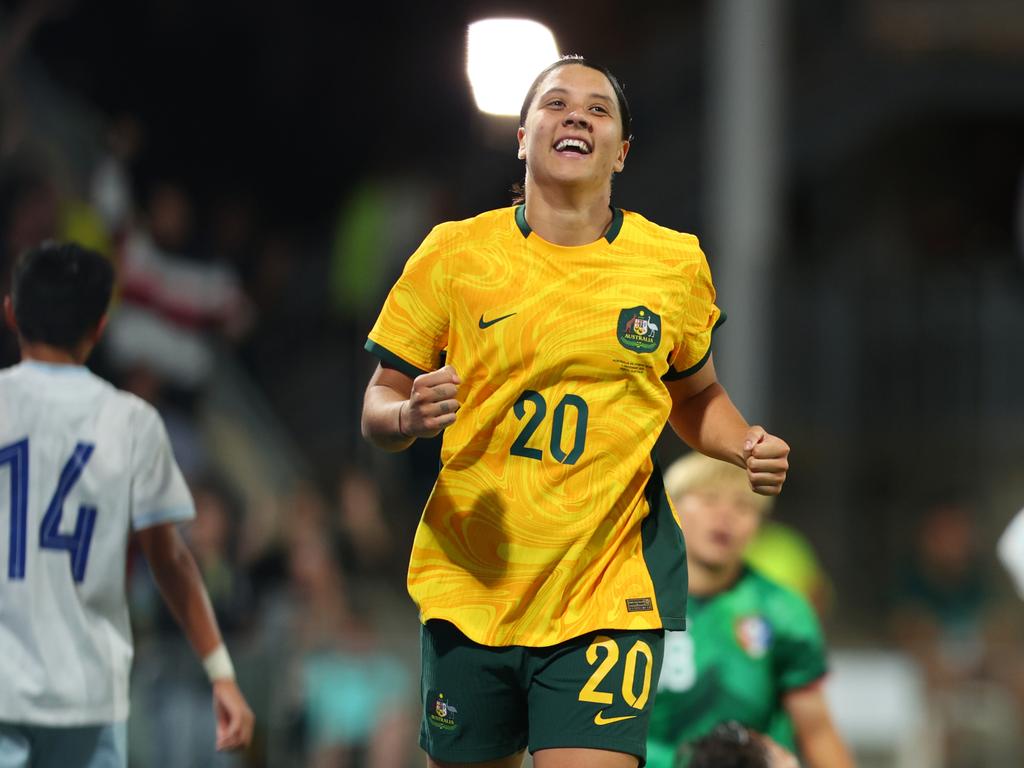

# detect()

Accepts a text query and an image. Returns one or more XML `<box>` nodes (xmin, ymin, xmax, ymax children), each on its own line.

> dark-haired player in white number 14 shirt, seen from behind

<box><xmin>0</xmin><ymin>244</ymin><xmax>253</xmax><ymax>768</ymax></box>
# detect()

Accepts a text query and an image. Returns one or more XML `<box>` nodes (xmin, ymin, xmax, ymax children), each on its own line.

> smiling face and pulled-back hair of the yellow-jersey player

<box><xmin>518</xmin><ymin>65</ymin><xmax>630</xmax><ymax>194</ymax></box>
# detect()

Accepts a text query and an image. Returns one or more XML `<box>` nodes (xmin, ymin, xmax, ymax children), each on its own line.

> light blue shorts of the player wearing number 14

<box><xmin>0</xmin><ymin>722</ymin><xmax>128</xmax><ymax>768</ymax></box>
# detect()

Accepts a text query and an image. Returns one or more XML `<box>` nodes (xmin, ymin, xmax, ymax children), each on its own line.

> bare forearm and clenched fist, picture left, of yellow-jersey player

<box><xmin>361</xmin><ymin>365</ymin><xmax>462</xmax><ymax>451</ymax></box>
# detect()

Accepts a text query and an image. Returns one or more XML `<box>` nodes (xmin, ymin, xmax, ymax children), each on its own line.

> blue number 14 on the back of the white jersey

<box><xmin>0</xmin><ymin>437</ymin><xmax>96</xmax><ymax>582</ymax></box>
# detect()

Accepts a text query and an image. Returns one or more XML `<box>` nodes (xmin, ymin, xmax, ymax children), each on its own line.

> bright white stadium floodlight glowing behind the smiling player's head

<box><xmin>466</xmin><ymin>18</ymin><xmax>558</xmax><ymax>115</ymax></box>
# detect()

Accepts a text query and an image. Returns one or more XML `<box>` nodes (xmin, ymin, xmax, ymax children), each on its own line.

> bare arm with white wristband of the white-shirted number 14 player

<box><xmin>135</xmin><ymin>523</ymin><xmax>253</xmax><ymax>750</ymax></box>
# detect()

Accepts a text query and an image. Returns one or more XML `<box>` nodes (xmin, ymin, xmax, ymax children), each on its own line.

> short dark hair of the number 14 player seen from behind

<box><xmin>11</xmin><ymin>242</ymin><xmax>114</xmax><ymax>349</ymax></box>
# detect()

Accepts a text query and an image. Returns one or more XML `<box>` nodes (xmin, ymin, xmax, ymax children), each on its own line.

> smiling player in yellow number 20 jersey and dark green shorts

<box><xmin>362</xmin><ymin>57</ymin><xmax>788</xmax><ymax>768</ymax></box>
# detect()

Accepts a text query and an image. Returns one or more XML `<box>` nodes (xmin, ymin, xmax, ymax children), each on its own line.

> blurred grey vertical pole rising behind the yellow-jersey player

<box><xmin>706</xmin><ymin>0</ymin><xmax>785</xmax><ymax>423</ymax></box>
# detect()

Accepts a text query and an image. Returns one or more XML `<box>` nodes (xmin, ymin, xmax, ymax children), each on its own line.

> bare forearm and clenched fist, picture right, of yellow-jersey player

<box><xmin>665</xmin><ymin>356</ymin><xmax>790</xmax><ymax>496</ymax></box>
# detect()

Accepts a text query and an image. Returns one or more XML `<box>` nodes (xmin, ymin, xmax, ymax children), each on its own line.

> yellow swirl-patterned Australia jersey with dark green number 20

<box><xmin>367</xmin><ymin>206</ymin><xmax>720</xmax><ymax>646</ymax></box>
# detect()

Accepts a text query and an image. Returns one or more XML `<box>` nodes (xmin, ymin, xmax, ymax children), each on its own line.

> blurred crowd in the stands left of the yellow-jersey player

<box><xmin>0</xmin><ymin>2</ymin><xmax>429</xmax><ymax>768</ymax></box>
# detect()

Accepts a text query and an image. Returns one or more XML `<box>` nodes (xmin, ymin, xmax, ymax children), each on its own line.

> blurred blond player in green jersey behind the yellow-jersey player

<box><xmin>647</xmin><ymin>454</ymin><xmax>853</xmax><ymax>768</ymax></box>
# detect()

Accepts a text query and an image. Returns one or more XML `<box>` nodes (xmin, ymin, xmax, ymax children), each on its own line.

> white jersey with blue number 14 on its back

<box><xmin>0</xmin><ymin>361</ymin><xmax>195</xmax><ymax>726</ymax></box>
